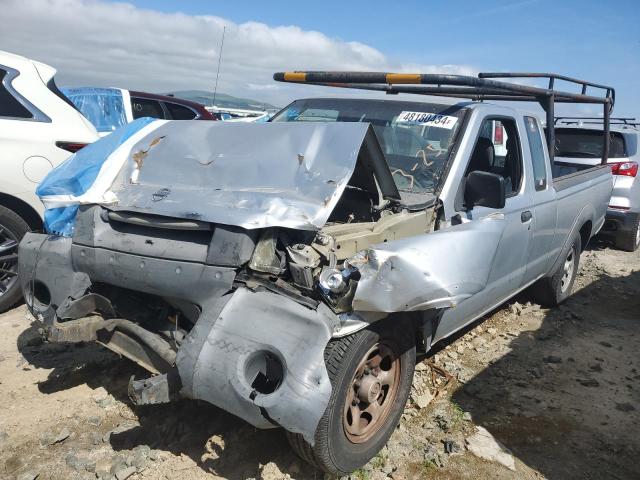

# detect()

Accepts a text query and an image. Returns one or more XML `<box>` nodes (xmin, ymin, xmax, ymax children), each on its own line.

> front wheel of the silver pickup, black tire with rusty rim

<box><xmin>288</xmin><ymin>318</ymin><xmax>416</xmax><ymax>475</ymax></box>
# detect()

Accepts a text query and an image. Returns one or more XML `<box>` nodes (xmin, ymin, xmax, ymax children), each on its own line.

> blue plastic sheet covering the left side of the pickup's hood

<box><xmin>36</xmin><ymin>117</ymin><xmax>156</xmax><ymax>237</ymax></box>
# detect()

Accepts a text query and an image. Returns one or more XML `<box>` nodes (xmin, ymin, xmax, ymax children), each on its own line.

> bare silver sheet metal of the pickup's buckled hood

<box><xmin>109</xmin><ymin>121</ymin><xmax>369</xmax><ymax>230</ymax></box>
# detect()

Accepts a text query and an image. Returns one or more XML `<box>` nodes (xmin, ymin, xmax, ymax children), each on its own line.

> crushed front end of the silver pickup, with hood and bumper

<box><xmin>19</xmin><ymin>122</ymin><xmax>422</xmax><ymax>443</ymax></box>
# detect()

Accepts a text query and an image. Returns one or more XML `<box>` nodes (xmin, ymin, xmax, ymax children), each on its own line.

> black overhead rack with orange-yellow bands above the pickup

<box><xmin>273</xmin><ymin>71</ymin><xmax>615</xmax><ymax>163</ymax></box>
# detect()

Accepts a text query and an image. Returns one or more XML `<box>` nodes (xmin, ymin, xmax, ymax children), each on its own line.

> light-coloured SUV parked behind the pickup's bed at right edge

<box><xmin>555</xmin><ymin>117</ymin><xmax>640</xmax><ymax>252</ymax></box>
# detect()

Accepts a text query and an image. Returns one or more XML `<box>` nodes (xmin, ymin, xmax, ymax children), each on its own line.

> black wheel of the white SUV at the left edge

<box><xmin>0</xmin><ymin>205</ymin><xmax>31</xmax><ymax>313</ymax></box>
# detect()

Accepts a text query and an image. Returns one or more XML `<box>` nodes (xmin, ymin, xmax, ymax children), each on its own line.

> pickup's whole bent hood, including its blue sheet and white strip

<box><xmin>37</xmin><ymin>118</ymin><xmax>400</xmax><ymax>236</ymax></box>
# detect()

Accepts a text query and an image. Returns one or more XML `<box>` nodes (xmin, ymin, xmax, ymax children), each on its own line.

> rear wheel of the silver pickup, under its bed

<box><xmin>533</xmin><ymin>233</ymin><xmax>582</xmax><ymax>307</ymax></box>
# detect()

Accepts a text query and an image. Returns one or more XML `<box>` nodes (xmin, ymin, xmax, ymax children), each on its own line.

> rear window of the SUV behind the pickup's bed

<box><xmin>555</xmin><ymin>128</ymin><xmax>626</xmax><ymax>158</ymax></box>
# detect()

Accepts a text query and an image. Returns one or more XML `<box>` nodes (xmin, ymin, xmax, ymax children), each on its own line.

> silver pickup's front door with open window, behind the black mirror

<box><xmin>467</xmin><ymin>117</ymin><xmax>532</xmax><ymax>308</ymax></box>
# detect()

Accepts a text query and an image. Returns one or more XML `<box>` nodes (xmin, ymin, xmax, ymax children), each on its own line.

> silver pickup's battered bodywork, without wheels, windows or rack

<box><xmin>19</xmin><ymin>100</ymin><xmax>612</xmax><ymax>444</ymax></box>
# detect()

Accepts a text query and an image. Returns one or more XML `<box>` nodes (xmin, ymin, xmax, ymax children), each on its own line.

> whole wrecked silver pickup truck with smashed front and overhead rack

<box><xmin>19</xmin><ymin>73</ymin><xmax>612</xmax><ymax>474</ymax></box>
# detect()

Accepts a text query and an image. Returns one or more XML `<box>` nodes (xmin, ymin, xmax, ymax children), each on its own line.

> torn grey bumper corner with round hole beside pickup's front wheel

<box><xmin>177</xmin><ymin>288</ymin><xmax>339</xmax><ymax>444</ymax></box>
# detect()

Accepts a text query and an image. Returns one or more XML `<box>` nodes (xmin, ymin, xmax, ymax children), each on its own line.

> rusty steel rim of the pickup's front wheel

<box><xmin>342</xmin><ymin>342</ymin><xmax>401</xmax><ymax>443</ymax></box>
